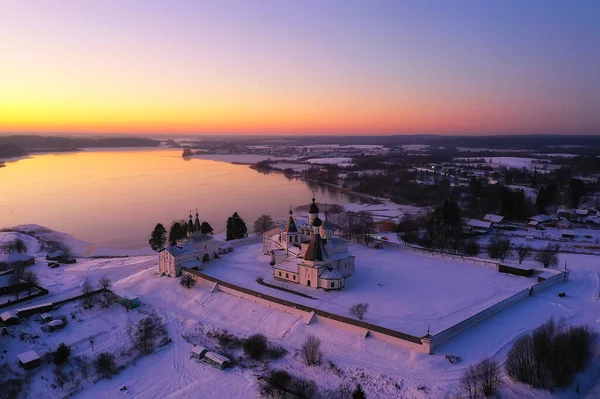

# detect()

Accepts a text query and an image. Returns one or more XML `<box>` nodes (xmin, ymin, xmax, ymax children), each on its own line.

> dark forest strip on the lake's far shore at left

<box><xmin>0</xmin><ymin>135</ymin><xmax>160</xmax><ymax>158</ymax></box>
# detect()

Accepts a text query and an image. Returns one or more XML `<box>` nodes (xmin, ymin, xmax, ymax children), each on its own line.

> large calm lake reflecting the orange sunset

<box><xmin>0</xmin><ymin>149</ymin><xmax>366</xmax><ymax>248</ymax></box>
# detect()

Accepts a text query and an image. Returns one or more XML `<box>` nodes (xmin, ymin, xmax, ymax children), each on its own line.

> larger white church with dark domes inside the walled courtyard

<box><xmin>263</xmin><ymin>198</ymin><xmax>354</xmax><ymax>290</ymax></box>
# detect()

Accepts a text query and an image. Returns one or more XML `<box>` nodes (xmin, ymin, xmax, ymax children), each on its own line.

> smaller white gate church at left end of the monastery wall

<box><xmin>158</xmin><ymin>211</ymin><xmax>220</xmax><ymax>277</ymax></box>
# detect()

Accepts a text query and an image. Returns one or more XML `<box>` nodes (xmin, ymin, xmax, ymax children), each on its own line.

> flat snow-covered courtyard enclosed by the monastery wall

<box><xmin>202</xmin><ymin>244</ymin><xmax>536</xmax><ymax>336</ymax></box>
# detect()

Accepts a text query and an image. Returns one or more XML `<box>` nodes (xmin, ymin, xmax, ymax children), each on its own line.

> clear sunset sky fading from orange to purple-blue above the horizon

<box><xmin>0</xmin><ymin>0</ymin><xmax>600</xmax><ymax>134</ymax></box>
